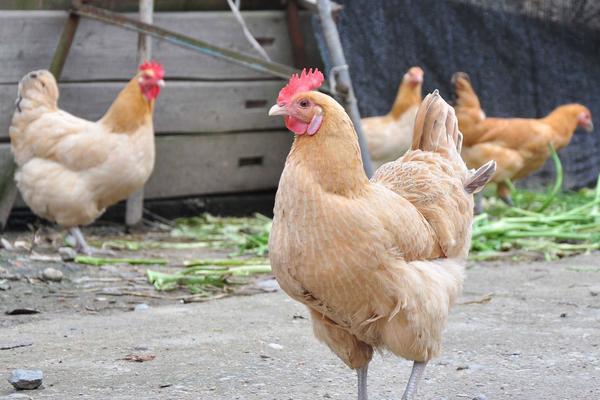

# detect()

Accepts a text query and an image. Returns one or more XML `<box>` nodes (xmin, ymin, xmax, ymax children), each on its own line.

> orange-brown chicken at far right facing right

<box><xmin>452</xmin><ymin>72</ymin><xmax>593</xmax><ymax>206</ymax></box>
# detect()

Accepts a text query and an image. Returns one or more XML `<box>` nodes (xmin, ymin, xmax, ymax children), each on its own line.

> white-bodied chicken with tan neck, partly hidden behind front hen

<box><xmin>361</xmin><ymin>67</ymin><xmax>423</xmax><ymax>169</ymax></box>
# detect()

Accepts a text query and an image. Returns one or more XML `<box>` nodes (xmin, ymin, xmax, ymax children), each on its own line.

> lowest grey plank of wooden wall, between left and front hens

<box><xmin>0</xmin><ymin>131</ymin><xmax>293</xmax><ymax>207</ymax></box>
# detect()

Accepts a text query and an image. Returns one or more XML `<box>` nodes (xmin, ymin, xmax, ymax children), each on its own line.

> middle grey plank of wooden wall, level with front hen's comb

<box><xmin>0</xmin><ymin>81</ymin><xmax>283</xmax><ymax>140</ymax></box>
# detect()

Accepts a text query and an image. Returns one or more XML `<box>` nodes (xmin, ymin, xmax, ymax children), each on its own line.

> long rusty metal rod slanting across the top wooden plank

<box><xmin>71</xmin><ymin>5</ymin><xmax>298</xmax><ymax>79</ymax></box>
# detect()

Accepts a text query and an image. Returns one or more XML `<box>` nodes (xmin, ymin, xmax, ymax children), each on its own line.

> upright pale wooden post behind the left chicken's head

<box><xmin>125</xmin><ymin>0</ymin><xmax>154</xmax><ymax>226</ymax></box>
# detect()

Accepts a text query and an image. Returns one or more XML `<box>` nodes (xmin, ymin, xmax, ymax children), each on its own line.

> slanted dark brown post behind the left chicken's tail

<box><xmin>0</xmin><ymin>10</ymin><xmax>79</xmax><ymax>230</ymax></box>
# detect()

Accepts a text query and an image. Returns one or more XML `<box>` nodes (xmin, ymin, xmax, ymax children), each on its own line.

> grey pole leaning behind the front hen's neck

<box><xmin>317</xmin><ymin>0</ymin><xmax>373</xmax><ymax>178</ymax></box>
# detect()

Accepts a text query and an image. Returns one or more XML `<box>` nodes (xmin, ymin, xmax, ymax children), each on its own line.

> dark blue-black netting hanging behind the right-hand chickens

<box><xmin>315</xmin><ymin>0</ymin><xmax>600</xmax><ymax>188</ymax></box>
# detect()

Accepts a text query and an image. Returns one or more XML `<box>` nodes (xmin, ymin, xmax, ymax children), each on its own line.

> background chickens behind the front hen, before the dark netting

<box><xmin>362</xmin><ymin>67</ymin><xmax>594</xmax><ymax>212</ymax></box>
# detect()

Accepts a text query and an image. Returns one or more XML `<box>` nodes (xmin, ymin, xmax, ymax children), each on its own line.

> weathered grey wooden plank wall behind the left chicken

<box><xmin>0</xmin><ymin>11</ymin><xmax>321</xmax><ymax>212</ymax></box>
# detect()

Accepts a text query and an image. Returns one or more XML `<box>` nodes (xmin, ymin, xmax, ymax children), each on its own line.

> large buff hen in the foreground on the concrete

<box><xmin>269</xmin><ymin>71</ymin><xmax>495</xmax><ymax>400</ymax></box>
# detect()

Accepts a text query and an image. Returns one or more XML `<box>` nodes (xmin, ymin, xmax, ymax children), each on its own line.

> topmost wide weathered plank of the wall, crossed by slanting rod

<box><xmin>0</xmin><ymin>11</ymin><xmax>312</xmax><ymax>83</ymax></box>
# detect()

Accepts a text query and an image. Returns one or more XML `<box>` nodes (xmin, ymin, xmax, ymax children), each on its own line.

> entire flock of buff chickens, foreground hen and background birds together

<box><xmin>5</xmin><ymin>62</ymin><xmax>592</xmax><ymax>400</ymax></box>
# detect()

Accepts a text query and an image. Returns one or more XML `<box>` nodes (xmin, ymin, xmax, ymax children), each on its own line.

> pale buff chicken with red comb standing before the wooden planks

<box><xmin>9</xmin><ymin>62</ymin><xmax>164</xmax><ymax>254</ymax></box>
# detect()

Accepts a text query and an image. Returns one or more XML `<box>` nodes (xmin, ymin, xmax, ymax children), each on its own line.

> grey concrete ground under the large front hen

<box><xmin>0</xmin><ymin>254</ymin><xmax>600</xmax><ymax>400</ymax></box>
